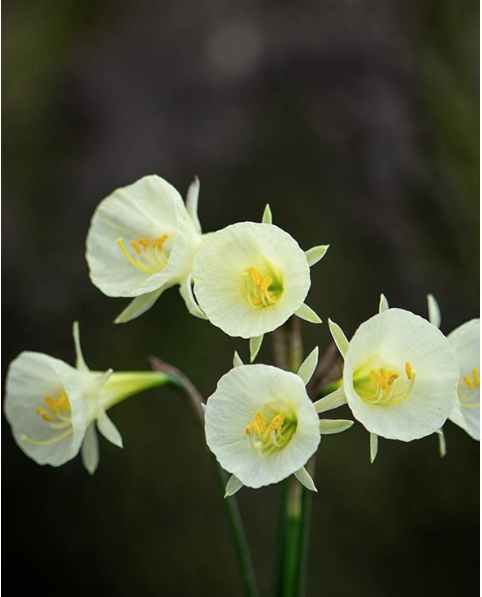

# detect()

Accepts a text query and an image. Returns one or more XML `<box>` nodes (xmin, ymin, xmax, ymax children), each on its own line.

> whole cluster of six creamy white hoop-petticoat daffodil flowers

<box><xmin>5</xmin><ymin>176</ymin><xmax>480</xmax><ymax>495</ymax></box>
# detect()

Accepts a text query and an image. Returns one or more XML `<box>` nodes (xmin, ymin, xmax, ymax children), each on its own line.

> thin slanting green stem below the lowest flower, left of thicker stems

<box><xmin>213</xmin><ymin>458</ymin><xmax>259</xmax><ymax>597</ymax></box>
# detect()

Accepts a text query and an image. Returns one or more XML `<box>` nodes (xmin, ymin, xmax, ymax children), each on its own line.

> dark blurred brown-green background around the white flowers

<box><xmin>2</xmin><ymin>0</ymin><xmax>479</xmax><ymax>597</ymax></box>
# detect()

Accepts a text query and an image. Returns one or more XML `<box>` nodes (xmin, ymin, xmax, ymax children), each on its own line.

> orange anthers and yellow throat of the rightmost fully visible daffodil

<box><xmin>354</xmin><ymin>362</ymin><xmax>415</xmax><ymax>406</ymax></box>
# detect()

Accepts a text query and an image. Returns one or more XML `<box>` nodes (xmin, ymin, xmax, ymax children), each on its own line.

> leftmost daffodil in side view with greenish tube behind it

<box><xmin>4</xmin><ymin>324</ymin><xmax>169</xmax><ymax>474</ymax></box>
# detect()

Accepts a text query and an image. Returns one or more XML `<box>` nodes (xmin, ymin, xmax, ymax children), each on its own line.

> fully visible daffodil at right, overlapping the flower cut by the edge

<box><xmin>315</xmin><ymin>304</ymin><xmax>459</xmax><ymax>462</ymax></box>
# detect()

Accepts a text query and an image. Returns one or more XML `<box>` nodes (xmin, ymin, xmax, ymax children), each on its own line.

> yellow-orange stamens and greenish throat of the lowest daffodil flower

<box><xmin>246</xmin><ymin>410</ymin><xmax>297</xmax><ymax>458</ymax></box>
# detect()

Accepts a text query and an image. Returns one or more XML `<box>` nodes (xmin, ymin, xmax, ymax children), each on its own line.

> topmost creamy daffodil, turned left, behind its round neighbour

<box><xmin>86</xmin><ymin>175</ymin><xmax>204</xmax><ymax>323</ymax></box>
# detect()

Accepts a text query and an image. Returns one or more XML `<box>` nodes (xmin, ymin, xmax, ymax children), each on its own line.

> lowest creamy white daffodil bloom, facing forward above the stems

<box><xmin>205</xmin><ymin>357</ymin><xmax>320</xmax><ymax>495</ymax></box>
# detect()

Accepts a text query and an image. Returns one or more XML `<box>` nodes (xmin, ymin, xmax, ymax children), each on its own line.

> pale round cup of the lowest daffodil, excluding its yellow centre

<box><xmin>205</xmin><ymin>365</ymin><xmax>320</xmax><ymax>488</ymax></box>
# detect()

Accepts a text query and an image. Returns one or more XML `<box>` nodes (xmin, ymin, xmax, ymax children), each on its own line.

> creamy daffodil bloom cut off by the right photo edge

<box><xmin>448</xmin><ymin>319</ymin><xmax>480</xmax><ymax>440</ymax></box>
